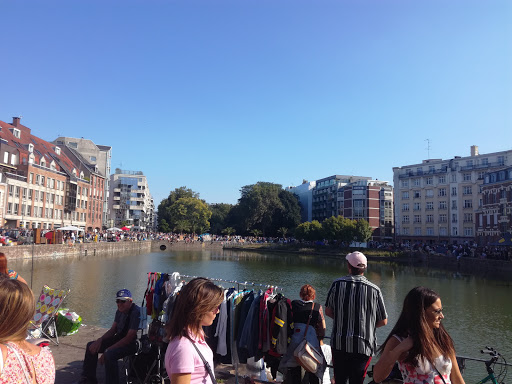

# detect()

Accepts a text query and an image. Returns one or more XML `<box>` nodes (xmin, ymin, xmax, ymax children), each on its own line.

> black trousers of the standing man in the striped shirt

<box><xmin>332</xmin><ymin>349</ymin><xmax>372</xmax><ymax>384</ymax></box>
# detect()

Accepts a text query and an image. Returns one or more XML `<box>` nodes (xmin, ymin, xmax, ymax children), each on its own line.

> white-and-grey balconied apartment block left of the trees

<box><xmin>109</xmin><ymin>168</ymin><xmax>154</xmax><ymax>231</ymax></box>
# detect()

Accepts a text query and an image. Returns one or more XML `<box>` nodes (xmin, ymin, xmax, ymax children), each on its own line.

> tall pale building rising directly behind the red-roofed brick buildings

<box><xmin>53</xmin><ymin>136</ymin><xmax>112</xmax><ymax>229</ymax></box>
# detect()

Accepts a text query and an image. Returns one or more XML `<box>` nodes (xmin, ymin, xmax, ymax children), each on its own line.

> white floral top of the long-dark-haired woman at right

<box><xmin>394</xmin><ymin>335</ymin><xmax>452</xmax><ymax>384</ymax></box>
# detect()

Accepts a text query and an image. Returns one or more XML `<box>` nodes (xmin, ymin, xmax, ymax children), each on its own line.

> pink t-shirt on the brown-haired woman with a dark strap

<box><xmin>165</xmin><ymin>336</ymin><xmax>213</xmax><ymax>384</ymax></box>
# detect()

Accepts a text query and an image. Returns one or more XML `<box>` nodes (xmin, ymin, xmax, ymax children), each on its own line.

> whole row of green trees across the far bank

<box><xmin>158</xmin><ymin>182</ymin><xmax>372</xmax><ymax>241</ymax></box>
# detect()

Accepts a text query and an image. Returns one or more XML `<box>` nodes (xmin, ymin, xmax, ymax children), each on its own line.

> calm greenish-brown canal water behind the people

<box><xmin>9</xmin><ymin>250</ymin><xmax>512</xmax><ymax>384</ymax></box>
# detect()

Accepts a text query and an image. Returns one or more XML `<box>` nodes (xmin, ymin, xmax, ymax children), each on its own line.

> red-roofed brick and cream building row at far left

<box><xmin>0</xmin><ymin>117</ymin><xmax>89</xmax><ymax>229</ymax></box>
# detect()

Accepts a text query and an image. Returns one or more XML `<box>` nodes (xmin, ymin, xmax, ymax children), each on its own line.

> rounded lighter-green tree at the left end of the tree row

<box><xmin>158</xmin><ymin>187</ymin><xmax>212</xmax><ymax>233</ymax></box>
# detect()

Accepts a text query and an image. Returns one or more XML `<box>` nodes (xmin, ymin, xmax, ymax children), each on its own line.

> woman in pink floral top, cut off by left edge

<box><xmin>0</xmin><ymin>277</ymin><xmax>55</xmax><ymax>384</ymax></box>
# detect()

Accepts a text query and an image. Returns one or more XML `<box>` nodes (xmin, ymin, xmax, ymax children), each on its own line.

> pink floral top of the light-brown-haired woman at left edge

<box><xmin>0</xmin><ymin>343</ymin><xmax>55</xmax><ymax>384</ymax></box>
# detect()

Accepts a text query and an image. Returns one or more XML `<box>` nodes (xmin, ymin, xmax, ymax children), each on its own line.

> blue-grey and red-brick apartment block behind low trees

<box><xmin>312</xmin><ymin>175</ymin><xmax>393</xmax><ymax>241</ymax></box>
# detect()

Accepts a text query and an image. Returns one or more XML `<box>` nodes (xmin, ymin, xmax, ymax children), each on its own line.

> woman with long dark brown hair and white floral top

<box><xmin>373</xmin><ymin>287</ymin><xmax>464</xmax><ymax>384</ymax></box>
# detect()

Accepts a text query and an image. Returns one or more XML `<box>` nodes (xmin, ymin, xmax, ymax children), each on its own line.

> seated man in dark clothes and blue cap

<box><xmin>79</xmin><ymin>289</ymin><xmax>140</xmax><ymax>384</ymax></box>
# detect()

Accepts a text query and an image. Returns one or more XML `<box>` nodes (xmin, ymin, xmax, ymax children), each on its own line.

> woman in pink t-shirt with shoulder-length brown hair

<box><xmin>165</xmin><ymin>277</ymin><xmax>224</xmax><ymax>384</ymax></box>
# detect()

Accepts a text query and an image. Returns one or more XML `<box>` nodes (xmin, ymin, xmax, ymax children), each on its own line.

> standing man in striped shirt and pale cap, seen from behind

<box><xmin>325</xmin><ymin>251</ymin><xmax>388</xmax><ymax>384</ymax></box>
